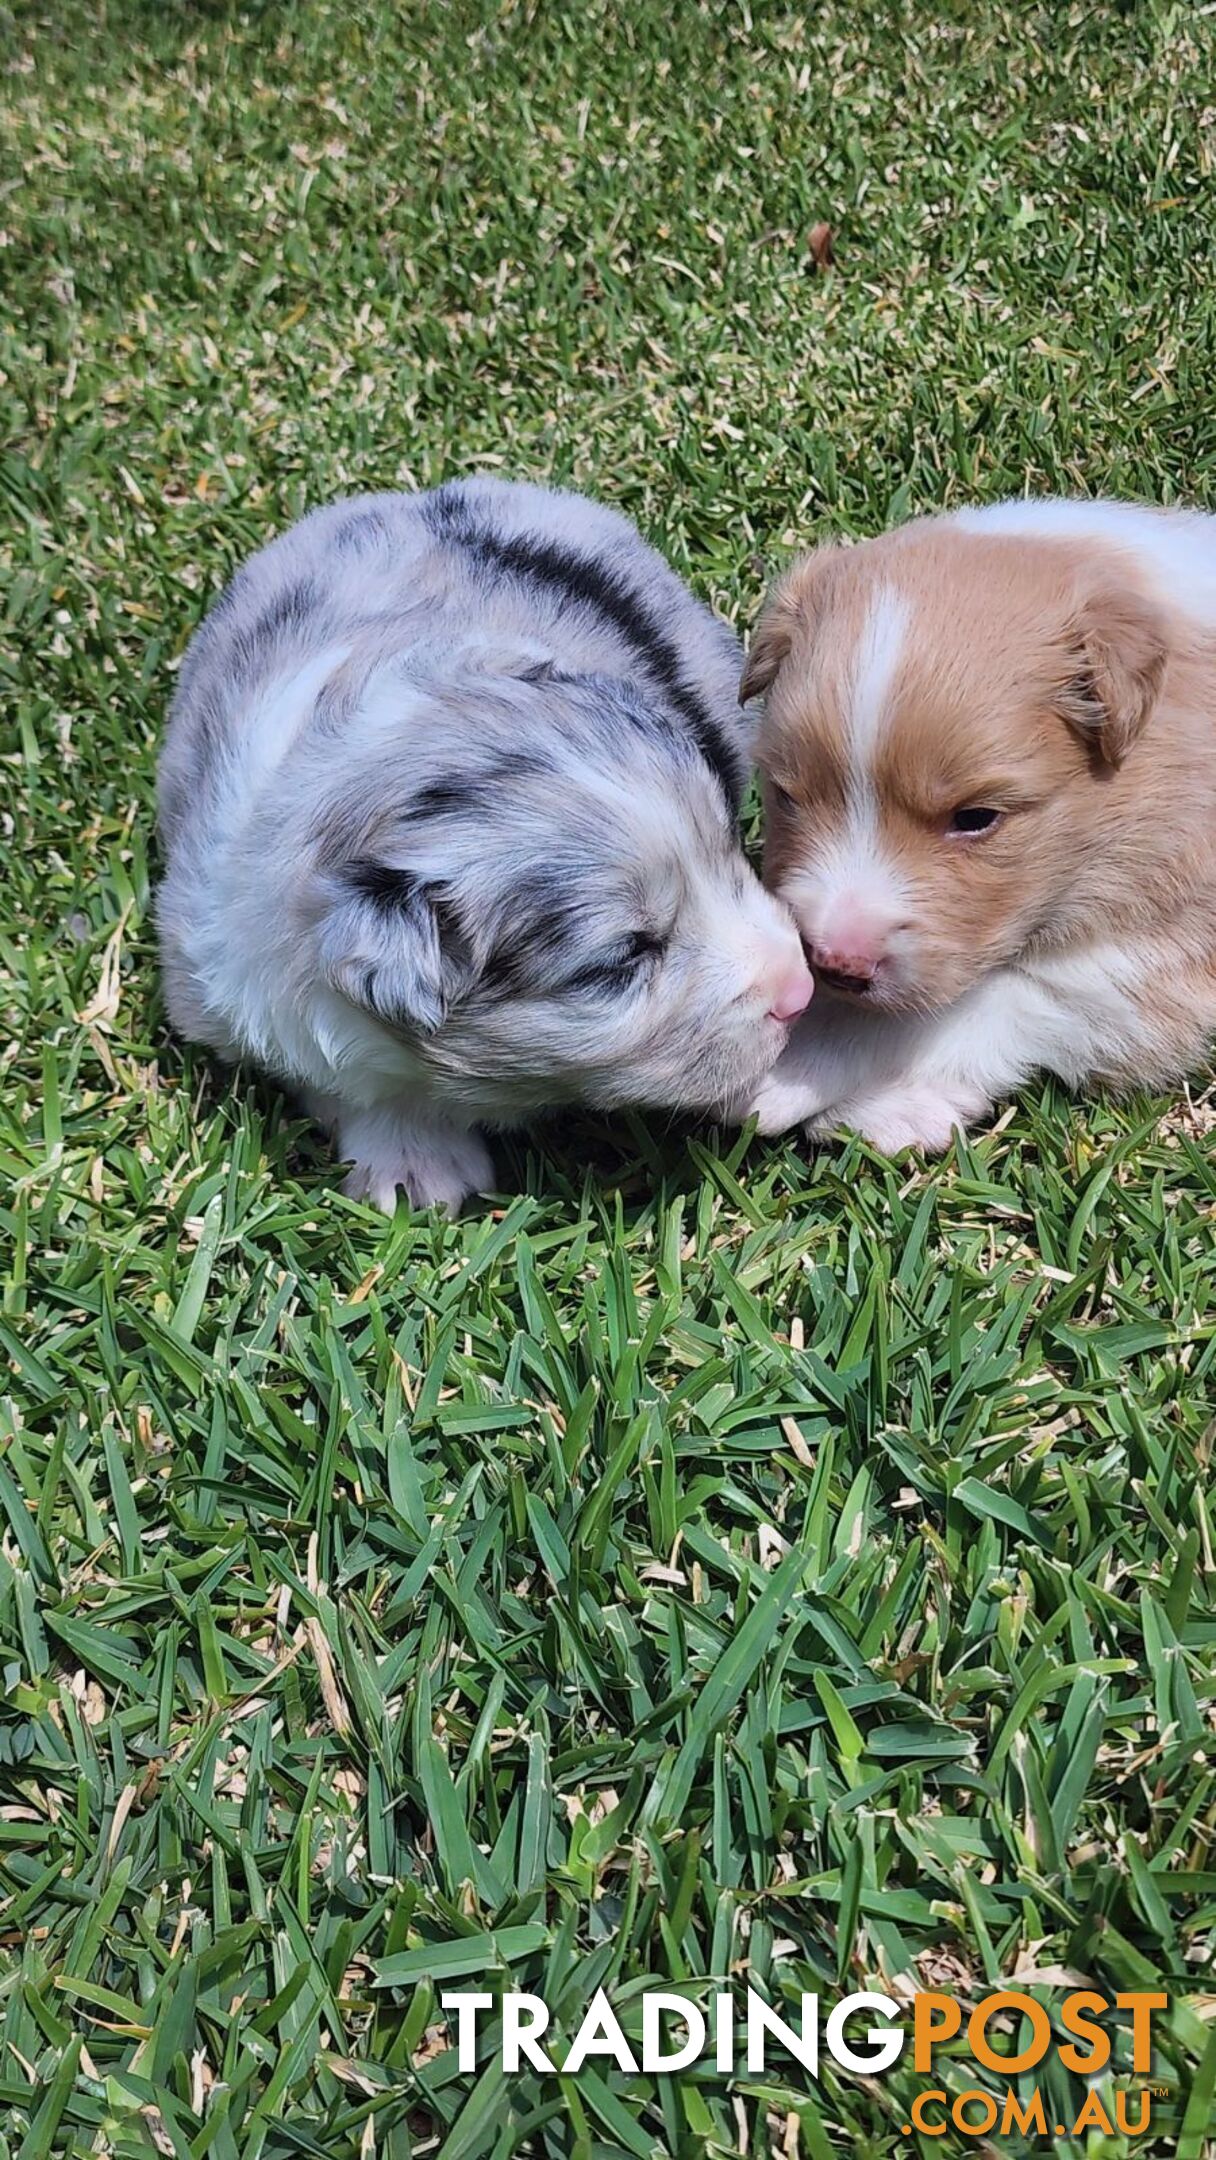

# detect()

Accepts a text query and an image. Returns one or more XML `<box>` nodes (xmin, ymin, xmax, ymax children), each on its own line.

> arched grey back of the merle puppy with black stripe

<box><xmin>158</xmin><ymin>475</ymin><xmax>749</xmax><ymax>855</ymax></box>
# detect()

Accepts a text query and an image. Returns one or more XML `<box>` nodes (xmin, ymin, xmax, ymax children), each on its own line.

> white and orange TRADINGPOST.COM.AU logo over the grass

<box><xmin>441</xmin><ymin>1987</ymin><xmax>1166</xmax><ymax>2138</ymax></box>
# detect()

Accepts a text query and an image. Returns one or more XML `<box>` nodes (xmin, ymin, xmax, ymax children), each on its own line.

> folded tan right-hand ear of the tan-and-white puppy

<box><xmin>1058</xmin><ymin>579</ymin><xmax>1168</xmax><ymax>765</ymax></box>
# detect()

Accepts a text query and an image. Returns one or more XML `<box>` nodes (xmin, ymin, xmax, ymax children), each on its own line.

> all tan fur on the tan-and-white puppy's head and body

<box><xmin>743</xmin><ymin>521</ymin><xmax>1216</xmax><ymax>1140</ymax></box>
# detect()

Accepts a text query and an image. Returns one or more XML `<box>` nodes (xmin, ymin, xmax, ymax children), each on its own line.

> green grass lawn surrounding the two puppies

<box><xmin>0</xmin><ymin>0</ymin><xmax>1216</xmax><ymax>2160</ymax></box>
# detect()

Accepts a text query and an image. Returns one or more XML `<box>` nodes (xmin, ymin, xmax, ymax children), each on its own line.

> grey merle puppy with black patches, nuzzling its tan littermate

<box><xmin>158</xmin><ymin>477</ymin><xmax>812</xmax><ymax>1212</ymax></box>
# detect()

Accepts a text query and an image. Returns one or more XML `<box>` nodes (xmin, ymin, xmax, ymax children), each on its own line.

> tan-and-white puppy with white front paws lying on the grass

<box><xmin>743</xmin><ymin>501</ymin><xmax>1216</xmax><ymax>1151</ymax></box>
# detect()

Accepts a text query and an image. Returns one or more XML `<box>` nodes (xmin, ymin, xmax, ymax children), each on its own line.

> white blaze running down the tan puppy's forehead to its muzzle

<box><xmin>782</xmin><ymin>585</ymin><xmax>909</xmax><ymax>967</ymax></box>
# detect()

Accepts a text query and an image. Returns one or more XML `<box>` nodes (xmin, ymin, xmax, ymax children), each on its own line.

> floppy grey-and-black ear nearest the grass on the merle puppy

<box><xmin>320</xmin><ymin>858</ymin><xmax>471</xmax><ymax>1035</ymax></box>
